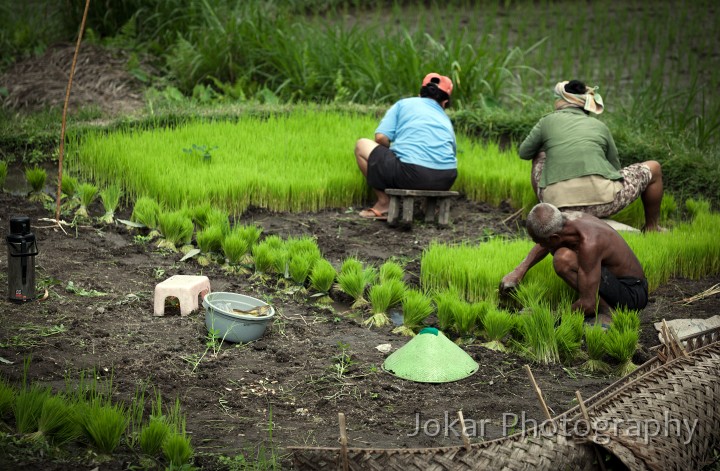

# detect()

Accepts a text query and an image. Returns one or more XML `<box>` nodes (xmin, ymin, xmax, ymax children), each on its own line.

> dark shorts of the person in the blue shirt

<box><xmin>367</xmin><ymin>146</ymin><xmax>457</xmax><ymax>191</ymax></box>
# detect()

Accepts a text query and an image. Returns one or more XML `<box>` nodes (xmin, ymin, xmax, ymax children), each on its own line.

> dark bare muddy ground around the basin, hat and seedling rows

<box><xmin>0</xmin><ymin>189</ymin><xmax>720</xmax><ymax>469</ymax></box>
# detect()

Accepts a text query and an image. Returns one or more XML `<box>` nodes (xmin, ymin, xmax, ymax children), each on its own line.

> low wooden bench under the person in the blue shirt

<box><xmin>385</xmin><ymin>188</ymin><xmax>460</xmax><ymax>226</ymax></box>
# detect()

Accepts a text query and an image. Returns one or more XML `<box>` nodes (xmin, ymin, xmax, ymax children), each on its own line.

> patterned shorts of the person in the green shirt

<box><xmin>531</xmin><ymin>152</ymin><xmax>652</xmax><ymax>218</ymax></box>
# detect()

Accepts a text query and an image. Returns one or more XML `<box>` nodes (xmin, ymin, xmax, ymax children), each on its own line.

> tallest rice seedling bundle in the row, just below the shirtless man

<box><xmin>518</xmin><ymin>301</ymin><xmax>560</xmax><ymax>364</ymax></box>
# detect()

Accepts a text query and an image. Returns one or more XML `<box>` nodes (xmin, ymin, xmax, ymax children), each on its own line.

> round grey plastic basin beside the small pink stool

<box><xmin>203</xmin><ymin>291</ymin><xmax>275</xmax><ymax>343</ymax></box>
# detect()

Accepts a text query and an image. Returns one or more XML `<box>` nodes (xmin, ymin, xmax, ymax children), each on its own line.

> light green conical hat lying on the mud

<box><xmin>383</xmin><ymin>327</ymin><xmax>479</xmax><ymax>383</ymax></box>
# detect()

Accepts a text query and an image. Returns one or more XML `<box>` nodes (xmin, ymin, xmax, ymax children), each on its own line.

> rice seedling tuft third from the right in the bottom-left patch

<box><xmin>78</xmin><ymin>399</ymin><xmax>128</xmax><ymax>454</ymax></box>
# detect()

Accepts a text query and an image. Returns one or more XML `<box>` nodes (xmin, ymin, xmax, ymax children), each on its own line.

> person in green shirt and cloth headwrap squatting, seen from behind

<box><xmin>518</xmin><ymin>80</ymin><xmax>663</xmax><ymax>231</ymax></box>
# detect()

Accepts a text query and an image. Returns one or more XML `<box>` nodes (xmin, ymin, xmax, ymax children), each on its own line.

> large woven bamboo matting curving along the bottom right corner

<box><xmin>289</xmin><ymin>329</ymin><xmax>720</xmax><ymax>471</ymax></box>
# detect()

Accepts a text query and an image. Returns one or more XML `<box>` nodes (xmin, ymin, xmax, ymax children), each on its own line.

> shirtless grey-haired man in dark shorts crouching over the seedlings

<box><xmin>500</xmin><ymin>203</ymin><xmax>648</xmax><ymax>324</ymax></box>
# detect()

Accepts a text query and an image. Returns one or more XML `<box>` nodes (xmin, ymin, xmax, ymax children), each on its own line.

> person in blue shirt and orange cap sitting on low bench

<box><xmin>355</xmin><ymin>73</ymin><xmax>457</xmax><ymax>219</ymax></box>
